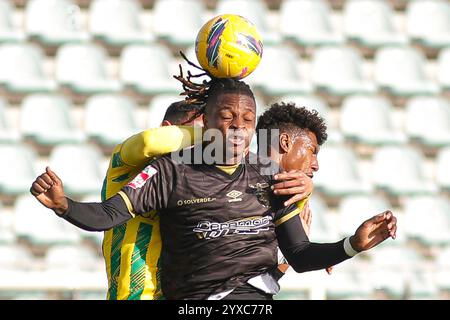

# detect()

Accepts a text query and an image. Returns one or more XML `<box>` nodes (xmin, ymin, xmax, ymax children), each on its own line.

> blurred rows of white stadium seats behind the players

<box><xmin>0</xmin><ymin>0</ymin><xmax>450</xmax><ymax>299</ymax></box>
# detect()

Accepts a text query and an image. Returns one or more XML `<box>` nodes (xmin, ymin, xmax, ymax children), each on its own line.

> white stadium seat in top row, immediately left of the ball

<box><xmin>153</xmin><ymin>0</ymin><xmax>206</xmax><ymax>46</ymax></box>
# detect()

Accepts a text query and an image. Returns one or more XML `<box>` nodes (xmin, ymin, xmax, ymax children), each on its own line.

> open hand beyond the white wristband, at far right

<box><xmin>350</xmin><ymin>210</ymin><xmax>397</xmax><ymax>251</ymax></box>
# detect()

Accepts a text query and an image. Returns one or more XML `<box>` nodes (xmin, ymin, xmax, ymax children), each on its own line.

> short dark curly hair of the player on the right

<box><xmin>256</xmin><ymin>102</ymin><xmax>328</xmax><ymax>145</ymax></box>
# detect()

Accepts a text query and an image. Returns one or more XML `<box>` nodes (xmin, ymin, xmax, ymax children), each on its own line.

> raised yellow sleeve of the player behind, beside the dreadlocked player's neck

<box><xmin>119</xmin><ymin>126</ymin><xmax>202</xmax><ymax>167</ymax></box>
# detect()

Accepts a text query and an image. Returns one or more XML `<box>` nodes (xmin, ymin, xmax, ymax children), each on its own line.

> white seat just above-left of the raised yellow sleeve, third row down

<box><xmin>84</xmin><ymin>94</ymin><xmax>140</xmax><ymax>146</ymax></box>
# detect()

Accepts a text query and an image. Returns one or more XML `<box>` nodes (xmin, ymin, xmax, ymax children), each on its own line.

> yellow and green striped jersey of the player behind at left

<box><xmin>102</xmin><ymin>126</ymin><xmax>201</xmax><ymax>300</ymax></box>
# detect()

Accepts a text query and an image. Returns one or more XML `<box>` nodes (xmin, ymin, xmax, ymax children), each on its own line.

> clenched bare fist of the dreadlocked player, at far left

<box><xmin>30</xmin><ymin>167</ymin><xmax>68</xmax><ymax>215</ymax></box>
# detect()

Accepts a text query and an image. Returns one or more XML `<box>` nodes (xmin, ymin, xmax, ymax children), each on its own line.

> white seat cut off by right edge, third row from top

<box><xmin>405</xmin><ymin>96</ymin><xmax>450</xmax><ymax>147</ymax></box>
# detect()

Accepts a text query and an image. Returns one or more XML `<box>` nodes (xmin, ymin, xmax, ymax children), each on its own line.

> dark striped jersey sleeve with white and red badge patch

<box><xmin>118</xmin><ymin>157</ymin><xmax>174</xmax><ymax>216</ymax></box>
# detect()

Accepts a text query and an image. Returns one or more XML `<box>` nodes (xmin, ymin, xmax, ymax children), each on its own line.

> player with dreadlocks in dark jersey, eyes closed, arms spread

<box><xmin>30</xmin><ymin>53</ymin><xmax>396</xmax><ymax>299</ymax></box>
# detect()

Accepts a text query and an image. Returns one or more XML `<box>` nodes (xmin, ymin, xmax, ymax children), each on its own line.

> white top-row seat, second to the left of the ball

<box><xmin>89</xmin><ymin>0</ymin><xmax>153</xmax><ymax>46</ymax></box>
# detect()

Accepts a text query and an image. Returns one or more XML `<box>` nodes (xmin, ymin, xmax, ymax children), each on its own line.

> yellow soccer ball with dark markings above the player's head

<box><xmin>195</xmin><ymin>14</ymin><xmax>263</xmax><ymax>79</ymax></box>
